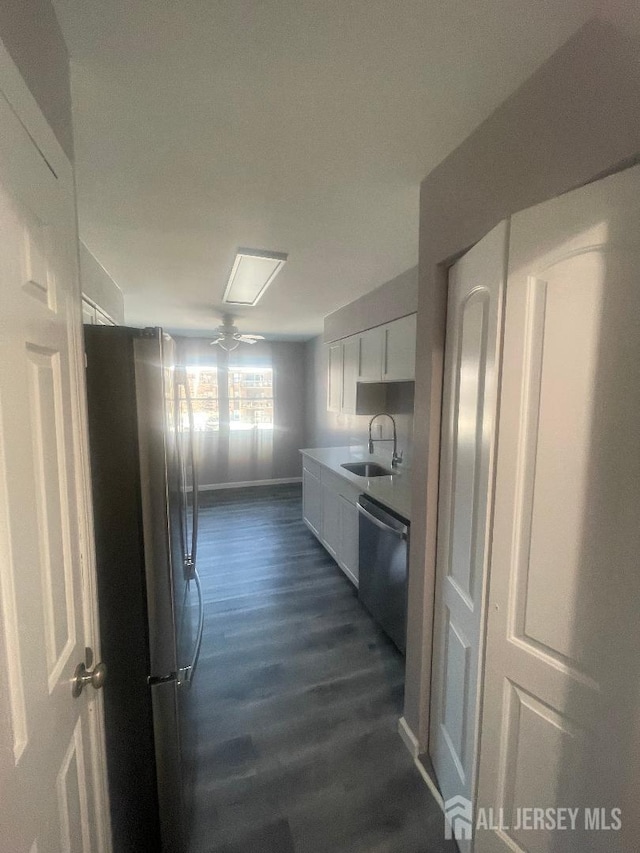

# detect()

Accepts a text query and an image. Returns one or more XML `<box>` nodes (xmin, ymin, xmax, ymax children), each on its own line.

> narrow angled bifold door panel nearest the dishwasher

<box><xmin>429</xmin><ymin>221</ymin><xmax>508</xmax><ymax>849</ymax></box>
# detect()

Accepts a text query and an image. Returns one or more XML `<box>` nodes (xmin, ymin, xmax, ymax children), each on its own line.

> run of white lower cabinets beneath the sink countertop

<box><xmin>302</xmin><ymin>457</ymin><xmax>360</xmax><ymax>586</ymax></box>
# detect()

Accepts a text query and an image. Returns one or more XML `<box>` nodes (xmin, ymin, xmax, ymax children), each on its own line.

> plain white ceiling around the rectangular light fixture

<box><xmin>54</xmin><ymin>0</ymin><xmax>596</xmax><ymax>339</ymax></box>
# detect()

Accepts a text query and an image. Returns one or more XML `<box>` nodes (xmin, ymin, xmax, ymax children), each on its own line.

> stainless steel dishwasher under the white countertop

<box><xmin>357</xmin><ymin>495</ymin><xmax>409</xmax><ymax>654</ymax></box>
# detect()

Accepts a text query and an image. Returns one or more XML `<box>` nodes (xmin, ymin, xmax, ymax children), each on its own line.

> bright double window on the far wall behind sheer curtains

<box><xmin>186</xmin><ymin>365</ymin><xmax>273</xmax><ymax>432</ymax></box>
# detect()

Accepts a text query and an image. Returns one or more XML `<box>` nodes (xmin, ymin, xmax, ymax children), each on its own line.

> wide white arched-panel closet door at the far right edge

<box><xmin>475</xmin><ymin>163</ymin><xmax>640</xmax><ymax>853</ymax></box>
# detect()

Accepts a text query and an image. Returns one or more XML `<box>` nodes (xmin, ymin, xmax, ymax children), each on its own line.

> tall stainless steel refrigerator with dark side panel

<box><xmin>85</xmin><ymin>326</ymin><xmax>204</xmax><ymax>853</ymax></box>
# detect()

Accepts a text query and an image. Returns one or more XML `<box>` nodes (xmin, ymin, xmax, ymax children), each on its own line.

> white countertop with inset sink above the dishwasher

<box><xmin>300</xmin><ymin>447</ymin><xmax>411</xmax><ymax>521</ymax></box>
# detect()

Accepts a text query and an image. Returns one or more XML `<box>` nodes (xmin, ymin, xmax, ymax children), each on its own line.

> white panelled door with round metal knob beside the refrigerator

<box><xmin>0</xmin><ymin>56</ymin><xmax>108</xmax><ymax>853</ymax></box>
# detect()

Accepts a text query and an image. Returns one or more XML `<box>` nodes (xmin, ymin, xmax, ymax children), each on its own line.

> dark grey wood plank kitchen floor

<box><xmin>192</xmin><ymin>485</ymin><xmax>456</xmax><ymax>853</ymax></box>
